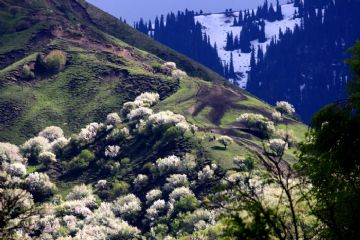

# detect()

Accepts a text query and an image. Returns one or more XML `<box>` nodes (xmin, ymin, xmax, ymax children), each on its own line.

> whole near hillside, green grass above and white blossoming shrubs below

<box><xmin>0</xmin><ymin>0</ymin><xmax>313</xmax><ymax>239</ymax></box>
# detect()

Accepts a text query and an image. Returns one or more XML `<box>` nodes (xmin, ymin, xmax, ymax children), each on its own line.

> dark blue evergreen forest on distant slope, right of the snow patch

<box><xmin>247</xmin><ymin>0</ymin><xmax>360</xmax><ymax>122</ymax></box>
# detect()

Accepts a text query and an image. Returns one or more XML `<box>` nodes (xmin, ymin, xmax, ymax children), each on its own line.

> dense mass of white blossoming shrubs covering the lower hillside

<box><xmin>0</xmin><ymin>91</ymin><xmax>300</xmax><ymax>240</ymax></box>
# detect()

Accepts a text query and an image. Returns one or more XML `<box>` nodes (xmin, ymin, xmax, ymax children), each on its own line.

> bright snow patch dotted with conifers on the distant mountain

<box><xmin>195</xmin><ymin>4</ymin><xmax>300</xmax><ymax>88</ymax></box>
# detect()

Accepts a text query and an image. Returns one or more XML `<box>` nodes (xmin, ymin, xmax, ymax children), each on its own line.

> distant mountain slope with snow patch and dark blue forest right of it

<box><xmin>133</xmin><ymin>0</ymin><xmax>360</xmax><ymax>122</ymax></box>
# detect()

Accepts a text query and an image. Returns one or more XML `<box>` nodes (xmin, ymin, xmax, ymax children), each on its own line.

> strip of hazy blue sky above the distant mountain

<box><xmin>88</xmin><ymin>0</ymin><xmax>286</xmax><ymax>24</ymax></box>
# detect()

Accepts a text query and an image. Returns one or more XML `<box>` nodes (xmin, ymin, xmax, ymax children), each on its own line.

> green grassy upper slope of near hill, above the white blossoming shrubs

<box><xmin>0</xmin><ymin>0</ymin><xmax>306</xmax><ymax>163</ymax></box>
